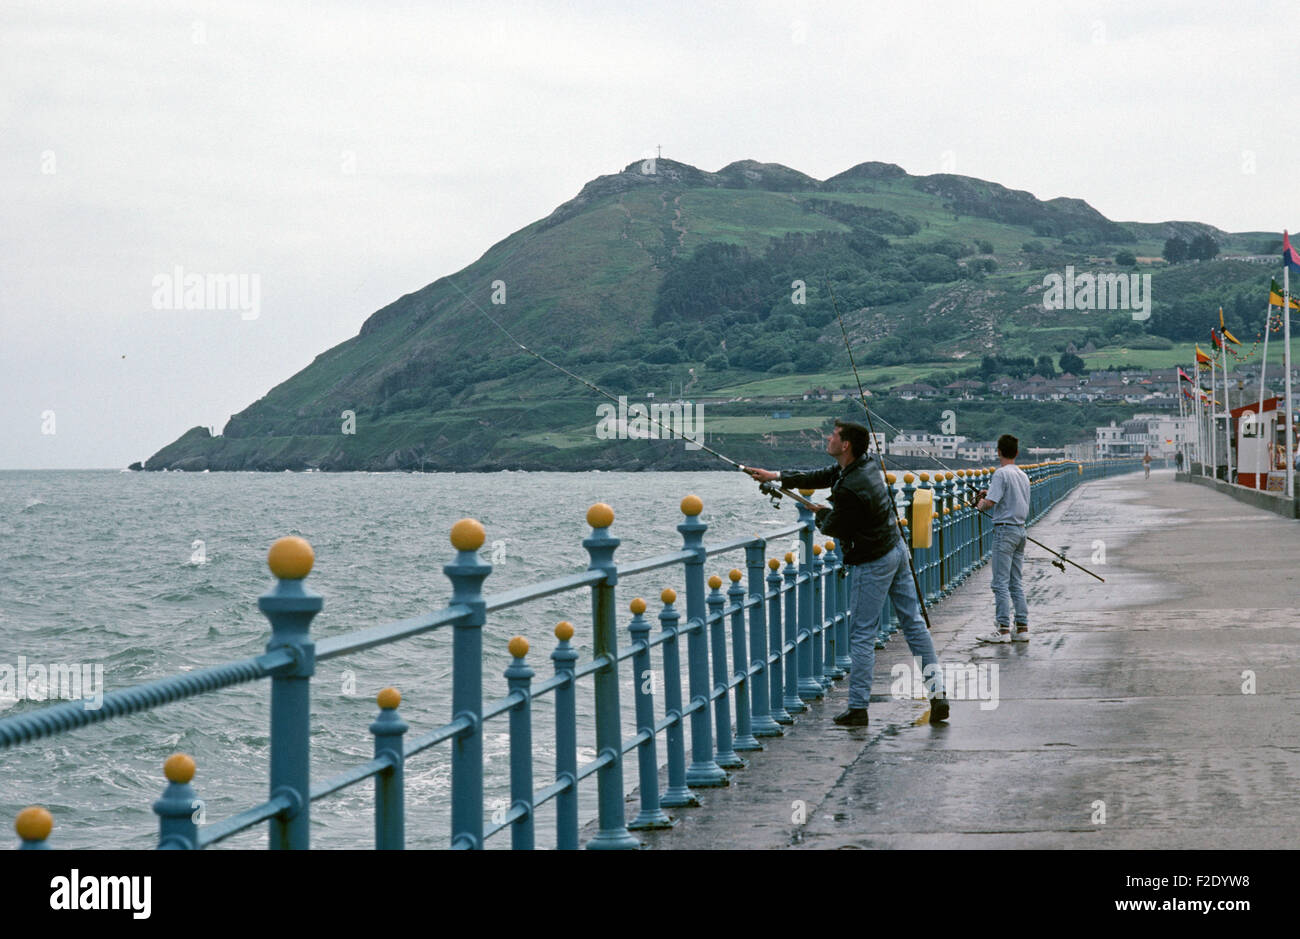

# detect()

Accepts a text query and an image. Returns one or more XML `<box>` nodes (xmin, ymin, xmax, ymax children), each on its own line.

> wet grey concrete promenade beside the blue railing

<box><xmin>603</xmin><ymin>471</ymin><xmax>1300</xmax><ymax>849</ymax></box>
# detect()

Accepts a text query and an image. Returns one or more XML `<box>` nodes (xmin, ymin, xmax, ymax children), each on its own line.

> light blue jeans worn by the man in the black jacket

<box><xmin>849</xmin><ymin>540</ymin><xmax>944</xmax><ymax>708</ymax></box>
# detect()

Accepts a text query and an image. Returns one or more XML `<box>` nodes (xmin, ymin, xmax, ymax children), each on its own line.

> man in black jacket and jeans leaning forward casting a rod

<box><xmin>745</xmin><ymin>420</ymin><xmax>948</xmax><ymax>727</ymax></box>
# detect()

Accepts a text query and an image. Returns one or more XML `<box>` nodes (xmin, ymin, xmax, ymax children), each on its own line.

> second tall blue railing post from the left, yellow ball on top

<box><xmin>442</xmin><ymin>519</ymin><xmax>491</xmax><ymax>849</ymax></box>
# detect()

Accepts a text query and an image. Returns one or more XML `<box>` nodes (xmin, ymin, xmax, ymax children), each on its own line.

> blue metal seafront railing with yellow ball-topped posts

<box><xmin>0</xmin><ymin>460</ymin><xmax>1140</xmax><ymax>849</ymax></box>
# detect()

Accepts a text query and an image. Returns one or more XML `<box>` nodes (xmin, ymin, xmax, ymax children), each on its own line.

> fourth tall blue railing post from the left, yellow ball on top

<box><xmin>677</xmin><ymin>496</ymin><xmax>731</xmax><ymax>787</ymax></box>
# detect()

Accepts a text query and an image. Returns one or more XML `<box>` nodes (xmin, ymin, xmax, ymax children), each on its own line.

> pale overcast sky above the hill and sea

<box><xmin>0</xmin><ymin>0</ymin><xmax>1300</xmax><ymax>468</ymax></box>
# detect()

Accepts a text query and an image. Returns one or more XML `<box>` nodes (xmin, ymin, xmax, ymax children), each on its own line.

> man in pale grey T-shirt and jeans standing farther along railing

<box><xmin>975</xmin><ymin>433</ymin><xmax>1030</xmax><ymax>642</ymax></box>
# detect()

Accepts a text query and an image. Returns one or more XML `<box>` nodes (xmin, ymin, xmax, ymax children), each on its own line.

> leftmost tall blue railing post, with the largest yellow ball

<box><xmin>257</xmin><ymin>536</ymin><xmax>324</xmax><ymax>851</ymax></box>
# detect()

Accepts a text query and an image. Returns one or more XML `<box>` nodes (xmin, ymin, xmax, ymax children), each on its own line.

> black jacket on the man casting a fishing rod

<box><xmin>781</xmin><ymin>455</ymin><xmax>900</xmax><ymax>564</ymax></box>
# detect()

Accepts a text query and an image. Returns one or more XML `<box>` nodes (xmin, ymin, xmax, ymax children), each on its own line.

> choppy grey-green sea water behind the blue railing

<box><xmin>0</xmin><ymin>468</ymin><xmax>811</xmax><ymax>848</ymax></box>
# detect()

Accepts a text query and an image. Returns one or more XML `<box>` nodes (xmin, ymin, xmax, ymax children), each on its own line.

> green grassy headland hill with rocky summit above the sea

<box><xmin>146</xmin><ymin>160</ymin><xmax>1277</xmax><ymax>470</ymax></box>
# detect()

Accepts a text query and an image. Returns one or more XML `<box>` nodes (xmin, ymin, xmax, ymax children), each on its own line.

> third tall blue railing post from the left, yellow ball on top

<box><xmin>582</xmin><ymin>502</ymin><xmax>641</xmax><ymax>851</ymax></box>
